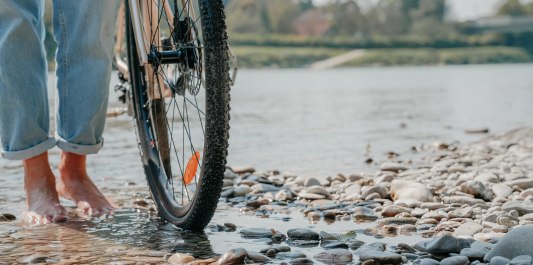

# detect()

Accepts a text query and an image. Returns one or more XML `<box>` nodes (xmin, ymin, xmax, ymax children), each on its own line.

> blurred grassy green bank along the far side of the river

<box><xmin>232</xmin><ymin>46</ymin><xmax>532</xmax><ymax>68</ymax></box>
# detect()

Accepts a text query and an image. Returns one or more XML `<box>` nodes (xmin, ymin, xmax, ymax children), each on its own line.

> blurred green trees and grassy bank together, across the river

<box><xmin>41</xmin><ymin>0</ymin><xmax>533</xmax><ymax>68</ymax></box>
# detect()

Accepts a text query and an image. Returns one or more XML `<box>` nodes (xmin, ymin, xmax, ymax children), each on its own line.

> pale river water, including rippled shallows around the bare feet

<box><xmin>0</xmin><ymin>65</ymin><xmax>533</xmax><ymax>264</ymax></box>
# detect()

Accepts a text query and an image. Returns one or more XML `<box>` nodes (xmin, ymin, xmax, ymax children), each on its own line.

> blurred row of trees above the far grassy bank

<box><xmin>225</xmin><ymin>0</ymin><xmax>533</xmax><ymax>38</ymax></box>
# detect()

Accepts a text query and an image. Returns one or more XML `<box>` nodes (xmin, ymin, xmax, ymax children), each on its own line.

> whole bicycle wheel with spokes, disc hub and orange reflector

<box><xmin>126</xmin><ymin>0</ymin><xmax>230</xmax><ymax>230</ymax></box>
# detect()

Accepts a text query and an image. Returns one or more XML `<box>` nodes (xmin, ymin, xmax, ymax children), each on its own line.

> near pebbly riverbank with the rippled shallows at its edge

<box><xmin>0</xmin><ymin>128</ymin><xmax>533</xmax><ymax>264</ymax></box>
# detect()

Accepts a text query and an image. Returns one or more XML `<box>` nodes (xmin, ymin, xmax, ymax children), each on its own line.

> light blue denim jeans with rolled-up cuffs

<box><xmin>0</xmin><ymin>0</ymin><xmax>120</xmax><ymax>160</ymax></box>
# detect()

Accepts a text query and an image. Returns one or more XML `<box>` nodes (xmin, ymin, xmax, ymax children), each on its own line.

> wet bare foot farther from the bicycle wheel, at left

<box><xmin>24</xmin><ymin>153</ymin><xmax>67</xmax><ymax>224</ymax></box>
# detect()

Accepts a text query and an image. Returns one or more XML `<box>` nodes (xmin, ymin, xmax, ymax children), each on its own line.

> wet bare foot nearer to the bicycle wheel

<box><xmin>56</xmin><ymin>152</ymin><xmax>115</xmax><ymax>216</ymax></box>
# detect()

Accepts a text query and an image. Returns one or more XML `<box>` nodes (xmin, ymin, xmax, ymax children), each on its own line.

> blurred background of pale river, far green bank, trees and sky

<box><xmin>39</xmin><ymin>0</ymin><xmax>533</xmax><ymax>177</ymax></box>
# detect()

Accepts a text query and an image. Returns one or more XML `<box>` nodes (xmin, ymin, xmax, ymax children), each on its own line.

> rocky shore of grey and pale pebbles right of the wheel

<box><xmin>194</xmin><ymin>129</ymin><xmax>533</xmax><ymax>265</ymax></box>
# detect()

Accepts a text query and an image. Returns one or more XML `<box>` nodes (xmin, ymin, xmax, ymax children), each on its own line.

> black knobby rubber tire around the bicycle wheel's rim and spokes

<box><xmin>126</xmin><ymin>0</ymin><xmax>230</xmax><ymax>231</ymax></box>
